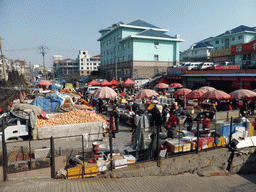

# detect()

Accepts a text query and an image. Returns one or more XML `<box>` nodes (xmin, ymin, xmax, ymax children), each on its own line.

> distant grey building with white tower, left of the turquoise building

<box><xmin>53</xmin><ymin>50</ymin><xmax>100</xmax><ymax>78</ymax></box>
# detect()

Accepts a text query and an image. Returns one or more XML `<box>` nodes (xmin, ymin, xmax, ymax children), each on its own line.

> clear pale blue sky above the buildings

<box><xmin>0</xmin><ymin>0</ymin><xmax>256</xmax><ymax>66</ymax></box>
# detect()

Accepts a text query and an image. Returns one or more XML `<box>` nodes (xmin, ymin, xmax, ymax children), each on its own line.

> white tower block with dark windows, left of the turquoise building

<box><xmin>78</xmin><ymin>50</ymin><xmax>100</xmax><ymax>76</ymax></box>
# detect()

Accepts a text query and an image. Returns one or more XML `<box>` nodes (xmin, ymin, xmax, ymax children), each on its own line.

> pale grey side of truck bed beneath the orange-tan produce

<box><xmin>37</xmin><ymin>122</ymin><xmax>103</xmax><ymax>141</ymax></box>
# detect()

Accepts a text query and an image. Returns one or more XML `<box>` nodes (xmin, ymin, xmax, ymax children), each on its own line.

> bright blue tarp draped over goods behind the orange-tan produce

<box><xmin>31</xmin><ymin>94</ymin><xmax>62</xmax><ymax>112</ymax></box>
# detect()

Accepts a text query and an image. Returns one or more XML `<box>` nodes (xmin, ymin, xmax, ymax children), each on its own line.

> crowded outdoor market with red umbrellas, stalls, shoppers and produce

<box><xmin>2</xmin><ymin>78</ymin><xmax>256</xmax><ymax>178</ymax></box>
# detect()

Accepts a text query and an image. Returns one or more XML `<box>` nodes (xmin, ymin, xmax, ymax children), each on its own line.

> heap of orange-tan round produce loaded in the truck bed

<box><xmin>36</xmin><ymin>110</ymin><xmax>106</xmax><ymax>127</ymax></box>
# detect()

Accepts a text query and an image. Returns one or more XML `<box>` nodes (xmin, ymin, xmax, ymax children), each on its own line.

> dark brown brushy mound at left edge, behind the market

<box><xmin>0</xmin><ymin>70</ymin><xmax>28</xmax><ymax>111</ymax></box>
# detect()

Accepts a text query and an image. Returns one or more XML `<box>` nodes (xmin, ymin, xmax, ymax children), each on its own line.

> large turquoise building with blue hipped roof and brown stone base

<box><xmin>98</xmin><ymin>20</ymin><xmax>184</xmax><ymax>80</ymax></box>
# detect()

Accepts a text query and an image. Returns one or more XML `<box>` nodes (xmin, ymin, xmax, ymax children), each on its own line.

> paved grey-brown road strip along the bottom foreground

<box><xmin>0</xmin><ymin>174</ymin><xmax>256</xmax><ymax>192</ymax></box>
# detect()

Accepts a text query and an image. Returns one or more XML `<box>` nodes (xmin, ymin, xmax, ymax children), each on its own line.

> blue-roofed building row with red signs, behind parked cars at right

<box><xmin>181</xmin><ymin>25</ymin><xmax>256</xmax><ymax>67</ymax></box>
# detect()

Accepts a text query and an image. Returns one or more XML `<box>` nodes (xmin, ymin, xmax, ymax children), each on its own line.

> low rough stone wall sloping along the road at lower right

<box><xmin>99</xmin><ymin>148</ymin><xmax>256</xmax><ymax>178</ymax></box>
